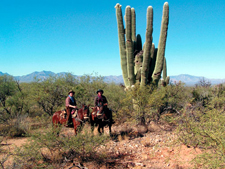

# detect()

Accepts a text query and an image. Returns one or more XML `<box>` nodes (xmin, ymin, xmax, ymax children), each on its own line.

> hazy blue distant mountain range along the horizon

<box><xmin>0</xmin><ymin>71</ymin><xmax>225</xmax><ymax>86</ymax></box>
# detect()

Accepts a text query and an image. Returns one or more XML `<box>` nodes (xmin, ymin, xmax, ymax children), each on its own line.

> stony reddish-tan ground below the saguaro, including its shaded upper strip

<box><xmin>1</xmin><ymin>123</ymin><xmax>201</xmax><ymax>169</ymax></box>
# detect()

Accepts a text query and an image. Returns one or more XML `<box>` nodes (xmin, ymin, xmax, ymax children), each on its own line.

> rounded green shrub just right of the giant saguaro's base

<box><xmin>148</xmin><ymin>83</ymin><xmax>192</xmax><ymax>123</ymax></box>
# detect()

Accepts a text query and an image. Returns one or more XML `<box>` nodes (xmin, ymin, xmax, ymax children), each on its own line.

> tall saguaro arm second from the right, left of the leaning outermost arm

<box><xmin>141</xmin><ymin>6</ymin><xmax>153</xmax><ymax>86</ymax></box>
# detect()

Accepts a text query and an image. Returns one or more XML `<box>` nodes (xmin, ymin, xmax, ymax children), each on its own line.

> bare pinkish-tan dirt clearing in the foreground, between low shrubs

<box><xmin>0</xmin><ymin>125</ymin><xmax>201</xmax><ymax>169</ymax></box>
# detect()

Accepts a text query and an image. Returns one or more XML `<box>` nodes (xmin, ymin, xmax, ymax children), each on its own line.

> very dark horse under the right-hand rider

<box><xmin>90</xmin><ymin>107</ymin><xmax>114</xmax><ymax>135</ymax></box>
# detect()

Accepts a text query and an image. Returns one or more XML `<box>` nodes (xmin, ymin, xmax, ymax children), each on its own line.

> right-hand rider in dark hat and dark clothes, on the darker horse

<box><xmin>95</xmin><ymin>89</ymin><xmax>108</xmax><ymax>116</ymax></box>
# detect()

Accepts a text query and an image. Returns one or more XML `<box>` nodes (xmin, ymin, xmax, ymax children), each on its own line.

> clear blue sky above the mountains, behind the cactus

<box><xmin>0</xmin><ymin>0</ymin><xmax>225</xmax><ymax>78</ymax></box>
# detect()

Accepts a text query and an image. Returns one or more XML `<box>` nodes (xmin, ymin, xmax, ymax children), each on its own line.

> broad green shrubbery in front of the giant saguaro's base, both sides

<box><xmin>119</xmin><ymin>83</ymin><xmax>192</xmax><ymax>124</ymax></box>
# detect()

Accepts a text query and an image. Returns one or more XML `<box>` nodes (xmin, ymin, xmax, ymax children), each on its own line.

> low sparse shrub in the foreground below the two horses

<box><xmin>14</xmin><ymin>127</ymin><xmax>108</xmax><ymax>168</ymax></box>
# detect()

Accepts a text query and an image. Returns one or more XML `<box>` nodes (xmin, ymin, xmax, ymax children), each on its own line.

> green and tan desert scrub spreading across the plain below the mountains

<box><xmin>0</xmin><ymin>73</ymin><xmax>225</xmax><ymax>168</ymax></box>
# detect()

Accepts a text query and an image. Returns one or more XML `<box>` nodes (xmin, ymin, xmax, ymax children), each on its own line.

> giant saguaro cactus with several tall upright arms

<box><xmin>115</xmin><ymin>2</ymin><xmax>169</xmax><ymax>87</ymax></box>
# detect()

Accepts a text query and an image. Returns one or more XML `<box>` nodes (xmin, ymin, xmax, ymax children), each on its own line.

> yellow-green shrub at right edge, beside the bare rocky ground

<box><xmin>177</xmin><ymin>109</ymin><xmax>225</xmax><ymax>168</ymax></box>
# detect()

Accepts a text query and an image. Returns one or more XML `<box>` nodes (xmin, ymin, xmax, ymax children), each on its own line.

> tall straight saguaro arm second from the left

<box><xmin>125</xmin><ymin>6</ymin><xmax>135</xmax><ymax>86</ymax></box>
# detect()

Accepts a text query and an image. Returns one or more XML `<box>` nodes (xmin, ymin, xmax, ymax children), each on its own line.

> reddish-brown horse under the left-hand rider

<box><xmin>52</xmin><ymin>105</ymin><xmax>89</xmax><ymax>134</ymax></box>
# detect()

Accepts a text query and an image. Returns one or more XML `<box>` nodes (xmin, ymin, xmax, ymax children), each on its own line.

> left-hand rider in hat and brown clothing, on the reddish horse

<box><xmin>66</xmin><ymin>90</ymin><xmax>77</xmax><ymax>126</ymax></box>
